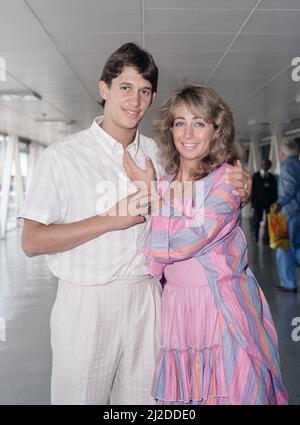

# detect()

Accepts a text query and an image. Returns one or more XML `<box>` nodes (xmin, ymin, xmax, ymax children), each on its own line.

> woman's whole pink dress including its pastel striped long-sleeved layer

<box><xmin>145</xmin><ymin>164</ymin><xmax>288</xmax><ymax>405</ymax></box>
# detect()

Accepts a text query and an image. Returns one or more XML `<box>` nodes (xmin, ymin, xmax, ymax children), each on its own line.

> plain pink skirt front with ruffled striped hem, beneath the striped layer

<box><xmin>153</xmin><ymin>258</ymin><xmax>227</xmax><ymax>404</ymax></box>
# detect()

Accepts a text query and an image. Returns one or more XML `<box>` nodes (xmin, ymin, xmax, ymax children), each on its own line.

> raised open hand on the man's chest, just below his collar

<box><xmin>123</xmin><ymin>151</ymin><xmax>156</xmax><ymax>189</ymax></box>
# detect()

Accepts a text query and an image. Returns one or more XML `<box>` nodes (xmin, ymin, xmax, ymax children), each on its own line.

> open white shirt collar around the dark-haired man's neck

<box><xmin>90</xmin><ymin>115</ymin><xmax>140</xmax><ymax>157</ymax></box>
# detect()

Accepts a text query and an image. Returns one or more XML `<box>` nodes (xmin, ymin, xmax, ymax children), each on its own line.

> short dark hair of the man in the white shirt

<box><xmin>100</xmin><ymin>42</ymin><xmax>158</xmax><ymax>106</ymax></box>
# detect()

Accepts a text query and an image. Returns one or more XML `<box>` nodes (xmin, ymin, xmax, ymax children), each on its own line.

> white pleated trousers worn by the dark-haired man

<box><xmin>50</xmin><ymin>276</ymin><xmax>161</xmax><ymax>404</ymax></box>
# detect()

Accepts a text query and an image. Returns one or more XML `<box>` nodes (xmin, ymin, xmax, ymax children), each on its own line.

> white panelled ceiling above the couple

<box><xmin>0</xmin><ymin>0</ymin><xmax>300</xmax><ymax>144</ymax></box>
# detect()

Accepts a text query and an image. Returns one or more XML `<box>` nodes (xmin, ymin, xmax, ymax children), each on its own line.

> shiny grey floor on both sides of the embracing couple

<box><xmin>0</xmin><ymin>220</ymin><xmax>300</xmax><ymax>404</ymax></box>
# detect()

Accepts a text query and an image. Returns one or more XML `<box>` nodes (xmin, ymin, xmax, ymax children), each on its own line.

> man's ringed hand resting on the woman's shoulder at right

<box><xmin>226</xmin><ymin>161</ymin><xmax>252</xmax><ymax>204</ymax></box>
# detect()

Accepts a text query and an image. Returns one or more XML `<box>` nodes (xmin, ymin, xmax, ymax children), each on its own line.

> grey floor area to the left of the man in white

<box><xmin>0</xmin><ymin>227</ymin><xmax>57</xmax><ymax>404</ymax></box>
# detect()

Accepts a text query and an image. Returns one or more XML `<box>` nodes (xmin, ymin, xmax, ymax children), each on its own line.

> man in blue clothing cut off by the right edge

<box><xmin>274</xmin><ymin>139</ymin><xmax>300</xmax><ymax>292</ymax></box>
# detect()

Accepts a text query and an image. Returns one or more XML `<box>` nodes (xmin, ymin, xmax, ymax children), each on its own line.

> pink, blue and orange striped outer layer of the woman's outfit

<box><xmin>145</xmin><ymin>164</ymin><xmax>288</xmax><ymax>405</ymax></box>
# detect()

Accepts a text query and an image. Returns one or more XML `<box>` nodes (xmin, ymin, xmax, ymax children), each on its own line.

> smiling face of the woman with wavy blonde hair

<box><xmin>172</xmin><ymin>104</ymin><xmax>215</xmax><ymax>161</ymax></box>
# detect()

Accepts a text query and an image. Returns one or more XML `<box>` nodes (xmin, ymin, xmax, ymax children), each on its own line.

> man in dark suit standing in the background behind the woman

<box><xmin>252</xmin><ymin>159</ymin><xmax>277</xmax><ymax>245</ymax></box>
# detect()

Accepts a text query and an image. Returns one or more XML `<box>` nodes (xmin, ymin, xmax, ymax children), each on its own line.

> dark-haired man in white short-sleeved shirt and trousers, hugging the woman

<box><xmin>20</xmin><ymin>43</ymin><xmax>251</xmax><ymax>404</ymax></box>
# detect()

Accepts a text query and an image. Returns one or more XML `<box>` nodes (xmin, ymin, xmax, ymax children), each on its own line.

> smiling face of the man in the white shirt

<box><xmin>99</xmin><ymin>66</ymin><xmax>154</xmax><ymax>130</ymax></box>
